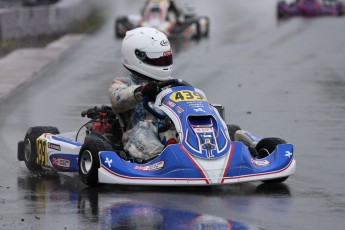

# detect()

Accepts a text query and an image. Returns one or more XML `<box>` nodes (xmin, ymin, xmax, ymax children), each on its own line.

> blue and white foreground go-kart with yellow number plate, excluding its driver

<box><xmin>18</xmin><ymin>79</ymin><xmax>296</xmax><ymax>186</ymax></box>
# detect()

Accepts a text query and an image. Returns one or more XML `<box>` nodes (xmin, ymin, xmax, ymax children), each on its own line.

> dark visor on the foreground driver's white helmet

<box><xmin>135</xmin><ymin>50</ymin><xmax>173</xmax><ymax>66</ymax></box>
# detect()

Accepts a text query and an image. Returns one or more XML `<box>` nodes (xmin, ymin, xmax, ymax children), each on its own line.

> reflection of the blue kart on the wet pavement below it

<box><xmin>17</xmin><ymin>175</ymin><xmax>290</xmax><ymax>230</ymax></box>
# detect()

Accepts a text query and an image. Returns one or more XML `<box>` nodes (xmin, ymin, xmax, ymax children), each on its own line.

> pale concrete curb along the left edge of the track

<box><xmin>0</xmin><ymin>34</ymin><xmax>85</xmax><ymax>103</ymax></box>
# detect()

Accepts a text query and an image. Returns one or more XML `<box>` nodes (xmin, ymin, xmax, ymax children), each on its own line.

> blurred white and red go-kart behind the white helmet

<box><xmin>114</xmin><ymin>0</ymin><xmax>210</xmax><ymax>39</ymax></box>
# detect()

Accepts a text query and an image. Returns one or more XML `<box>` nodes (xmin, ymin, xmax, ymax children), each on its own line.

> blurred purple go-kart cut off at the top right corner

<box><xmin>277</xmin><ymin>0</ymin><xmax>344</xmax><ymax>19</ymax></box>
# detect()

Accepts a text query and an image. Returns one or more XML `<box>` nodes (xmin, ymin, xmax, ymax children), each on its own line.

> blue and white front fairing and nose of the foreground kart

<box><xmin>99</xmin><ymin>86</ymin><xmax>296</xmax><ymax>186</ymax></box>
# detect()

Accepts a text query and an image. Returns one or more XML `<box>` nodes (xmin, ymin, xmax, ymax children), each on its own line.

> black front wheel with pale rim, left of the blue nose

<box><xmin>78</xmin><ymin>137</ymin><xmax>113</xmax><ymax>186</ymax></box>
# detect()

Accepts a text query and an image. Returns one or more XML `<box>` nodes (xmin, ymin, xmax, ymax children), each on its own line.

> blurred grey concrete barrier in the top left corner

<box><xmin>0</xmin><ymin>0</ymin><xmax>97</xmax><ymax>40</ymax></box>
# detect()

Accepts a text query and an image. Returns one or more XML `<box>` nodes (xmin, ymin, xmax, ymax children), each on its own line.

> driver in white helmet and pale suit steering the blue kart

<box><xmin>108</xmin><ymin>27</ymin><xmax>173</xmax><ymax>162</ymax></box>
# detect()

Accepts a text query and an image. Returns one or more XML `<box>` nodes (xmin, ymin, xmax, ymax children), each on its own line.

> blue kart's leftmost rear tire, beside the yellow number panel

<box><xmin>24</xmin><ymin>126</ymin><xmax>60</xmax><ymax>173</ymax></box>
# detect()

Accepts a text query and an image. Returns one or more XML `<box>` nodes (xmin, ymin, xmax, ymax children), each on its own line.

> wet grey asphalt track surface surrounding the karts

<box><xmin>0</xmin><ymin>0</ymin><xmax>345</xmax><ymax>229</ymax></box>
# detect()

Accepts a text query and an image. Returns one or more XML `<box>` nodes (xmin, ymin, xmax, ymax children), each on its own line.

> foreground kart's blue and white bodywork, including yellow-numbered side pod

<box><xmin>18</xmin><ymin>80</ymin><xmax>296</xmax><ymax>186</ymax></box>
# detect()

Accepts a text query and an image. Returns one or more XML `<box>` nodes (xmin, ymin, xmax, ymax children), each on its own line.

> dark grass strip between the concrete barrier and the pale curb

<box><xmin>0</xmin><ymin>10</ymin><xmax>104</xmax><ymax>57</ymax></box>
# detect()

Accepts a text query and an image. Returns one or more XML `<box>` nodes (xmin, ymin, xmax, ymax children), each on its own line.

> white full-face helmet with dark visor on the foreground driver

<box><xmin>121</xmin><ymin>27</ymin><xmax>173</xmax><ymax>81</ymax></box>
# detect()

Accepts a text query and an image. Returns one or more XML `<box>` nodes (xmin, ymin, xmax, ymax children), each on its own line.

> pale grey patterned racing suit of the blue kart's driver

<box><xmin>108</xmin><ymin>74</ymin><xmax>164</xmax><ymax>159</ymax></box>
